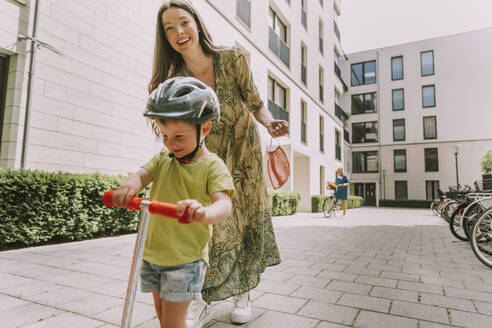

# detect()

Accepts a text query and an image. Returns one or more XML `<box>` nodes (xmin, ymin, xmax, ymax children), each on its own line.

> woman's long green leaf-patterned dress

<box><xmin>173</xmin><ymin>49</ymin><xmax>280</xmax><ymax>302</ymax></box>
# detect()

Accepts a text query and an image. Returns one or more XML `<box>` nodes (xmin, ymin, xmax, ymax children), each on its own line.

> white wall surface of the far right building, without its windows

<box><xmin>341</xmin><ymin>28</ymin><xmax>492</xmax><ymax>204</ymax></box>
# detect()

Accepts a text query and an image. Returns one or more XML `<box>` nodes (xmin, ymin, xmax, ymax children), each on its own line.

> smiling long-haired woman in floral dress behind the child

<box><xmin>149</xmin><ymin>0</ymin><xmax>288</xmax><ymax>323</ymax></box>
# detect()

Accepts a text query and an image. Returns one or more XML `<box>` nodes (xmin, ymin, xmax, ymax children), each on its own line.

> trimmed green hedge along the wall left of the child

<box><xmin>0</xmin><ymin>170</ymin><xmax>149</xmax><ymax>250</ymax></box>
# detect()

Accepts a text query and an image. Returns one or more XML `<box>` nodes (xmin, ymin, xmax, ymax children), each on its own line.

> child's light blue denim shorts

<box><xmin>140</xmin><ymin>260</ymin><xmax>207</xmax><ymax>302</ymax></box>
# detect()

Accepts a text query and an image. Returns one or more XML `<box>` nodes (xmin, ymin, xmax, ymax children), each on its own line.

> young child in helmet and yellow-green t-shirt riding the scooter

<box><xmin>113</xmin><ymin>77</ymin><xmax>234</xmax><ymax>328</ymax></box>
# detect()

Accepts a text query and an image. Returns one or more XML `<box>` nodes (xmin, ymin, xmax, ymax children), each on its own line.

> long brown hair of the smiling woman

<box><xmin>148</xmin><ymin>0</ymin><xmax>221</xmax><ymax>93</ymax></box>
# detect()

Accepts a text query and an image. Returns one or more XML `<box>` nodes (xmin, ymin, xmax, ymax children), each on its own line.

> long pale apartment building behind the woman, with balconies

<box><xmin>0</xmin><ymin>0</ymin><xmax>348</xmax><ymax>210</ymax></box>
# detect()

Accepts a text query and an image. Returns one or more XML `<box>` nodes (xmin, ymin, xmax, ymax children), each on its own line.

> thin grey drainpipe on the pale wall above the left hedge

<box><xmin>21</xmin><ymin>0</ymin><xmax>40</xmax><ymax>169</ymax></box>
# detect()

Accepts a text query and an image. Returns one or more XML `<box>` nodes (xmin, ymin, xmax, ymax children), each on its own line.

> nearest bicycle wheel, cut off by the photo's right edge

<box><xmin>471</xmin><ymin>207</ymin><xmax>492</xmax><ymax>268</ymax></box>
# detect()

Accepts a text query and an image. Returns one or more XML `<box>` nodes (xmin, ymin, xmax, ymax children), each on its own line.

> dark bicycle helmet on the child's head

<box><xmin>144</xmin><ymin>77</ymin><xmax>220</xmax><ymax>124</ymax></box>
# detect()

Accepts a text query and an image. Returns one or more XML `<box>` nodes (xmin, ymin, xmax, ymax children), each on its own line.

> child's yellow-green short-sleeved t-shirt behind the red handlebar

<box><xmin>142</xmin><ymin>151</ymin><xmax>234</xmax><ymax>266</ymax></box>
